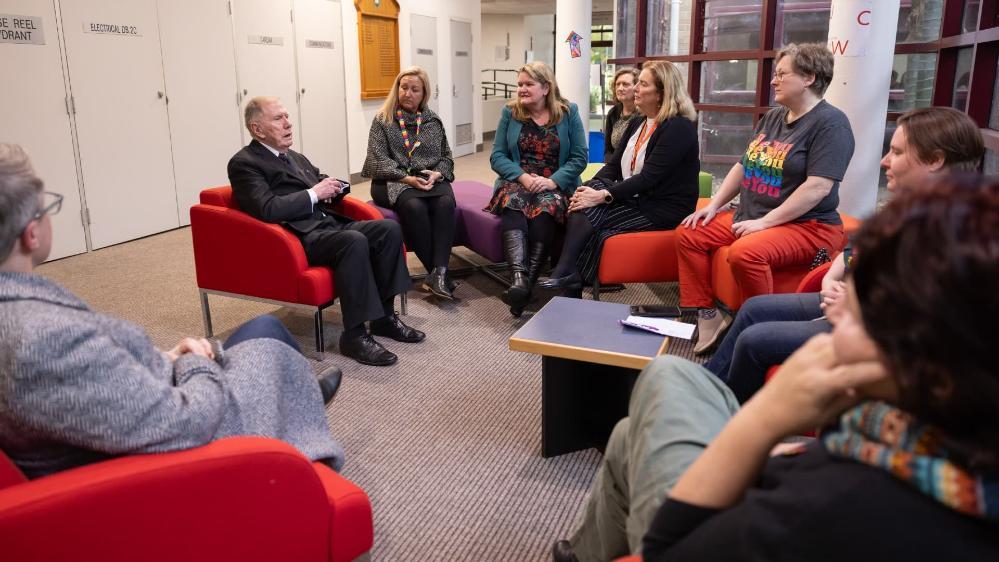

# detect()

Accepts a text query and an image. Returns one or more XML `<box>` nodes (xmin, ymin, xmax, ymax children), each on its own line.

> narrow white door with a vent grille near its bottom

<box><xmin>448</xmin><ymin>20</ymin><xmax>477</xmax><ymax>157</ymax></box>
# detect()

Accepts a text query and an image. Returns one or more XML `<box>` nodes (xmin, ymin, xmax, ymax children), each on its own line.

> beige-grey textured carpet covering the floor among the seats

<box><xmin>39</xmin><ymin>142</ymin><xmax>704</xmax><ymax>561</ymax></box>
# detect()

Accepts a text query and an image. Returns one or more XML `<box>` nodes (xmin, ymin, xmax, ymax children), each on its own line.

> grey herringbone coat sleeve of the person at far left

<box><xmin>5</xmin><ymin>324</ymin><xmax>229</xmax><ymax>454</ymax></box>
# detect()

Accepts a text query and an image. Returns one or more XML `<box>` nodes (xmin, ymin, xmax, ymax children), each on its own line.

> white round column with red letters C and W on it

<box><xmin>825</xmin><ymin>0</ymin><xmax>899</xmax><ymax>218</ymax></box>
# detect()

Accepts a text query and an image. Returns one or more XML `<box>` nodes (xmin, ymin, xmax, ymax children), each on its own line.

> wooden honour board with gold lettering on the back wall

<box><xmin>354</xmin><ymin>0</ymin><xmax>399</xmax><ymax>100</ymax></box>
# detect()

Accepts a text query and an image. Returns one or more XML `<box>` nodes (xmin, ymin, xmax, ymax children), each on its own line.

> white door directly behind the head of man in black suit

<box><xmin>232</xmin><ymin>0</ymin><xmax>305</xmax><ymax>148</ymax></box>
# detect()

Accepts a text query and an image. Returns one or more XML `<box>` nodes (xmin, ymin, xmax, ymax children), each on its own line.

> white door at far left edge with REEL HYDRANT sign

<box><xmin>0</xmin><ymin>0</ymin><xmax>87</xmax><ymax>259</ymax></box>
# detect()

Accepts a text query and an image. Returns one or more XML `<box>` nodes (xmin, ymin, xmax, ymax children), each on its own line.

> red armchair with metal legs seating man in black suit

<box><xmin>191</xmin><ymin>185</ymin><xmax>398</xmax><ymax>353</ymax></box>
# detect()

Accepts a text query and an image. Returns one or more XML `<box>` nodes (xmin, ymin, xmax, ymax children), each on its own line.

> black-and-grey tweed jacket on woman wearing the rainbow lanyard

<box><xmin>361</xmin><ymin>107</ymin><xmax>454</xmax><ymax>205</ymax></box>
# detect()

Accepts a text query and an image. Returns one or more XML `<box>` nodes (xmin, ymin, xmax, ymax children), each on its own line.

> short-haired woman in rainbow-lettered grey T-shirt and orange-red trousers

<box><xmin>677</xmin><ymin>43</ymin><xmax>854</xmax><ymax>353</ymax></box>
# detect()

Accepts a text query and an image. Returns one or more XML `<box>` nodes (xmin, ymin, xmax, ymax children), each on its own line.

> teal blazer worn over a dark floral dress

<box><xmin>489</xmin><ymin>103</ymin><xmax>587</xmax><ymax>196</ymax></box>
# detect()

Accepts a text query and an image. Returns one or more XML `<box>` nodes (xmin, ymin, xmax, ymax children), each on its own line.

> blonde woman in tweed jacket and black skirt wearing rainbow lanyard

<box><xmin>361</xmin><ymin>66</ymin><xmax>455</xmax><ymax>300</ymax></box>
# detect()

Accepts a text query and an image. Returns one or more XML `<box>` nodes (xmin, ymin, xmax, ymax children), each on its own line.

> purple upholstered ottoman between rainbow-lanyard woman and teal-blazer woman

<box><xmin>368</xmin><ymin>180</ymin><xmax>504</xmax><ymax>263</ymax></box>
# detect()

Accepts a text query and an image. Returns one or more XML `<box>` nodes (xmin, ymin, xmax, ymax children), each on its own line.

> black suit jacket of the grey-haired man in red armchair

<box><xmin>228</xmin><ymin>140</ymin><xmax>350</xmax><ymax>236</ymax></box>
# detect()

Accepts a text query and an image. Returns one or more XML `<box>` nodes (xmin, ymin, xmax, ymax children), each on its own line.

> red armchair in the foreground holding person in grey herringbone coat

<box><xmin>0</xmin><ymin>437</ymin><xmax>373</xmax><ymax>562</ymax></box>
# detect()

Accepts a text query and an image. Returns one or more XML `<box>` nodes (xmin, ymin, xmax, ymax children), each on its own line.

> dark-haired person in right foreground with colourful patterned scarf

<box><xmin>554</xmin><ymin>177</ymin><xmax>999</xmax><ymax>562</ymax></box>
